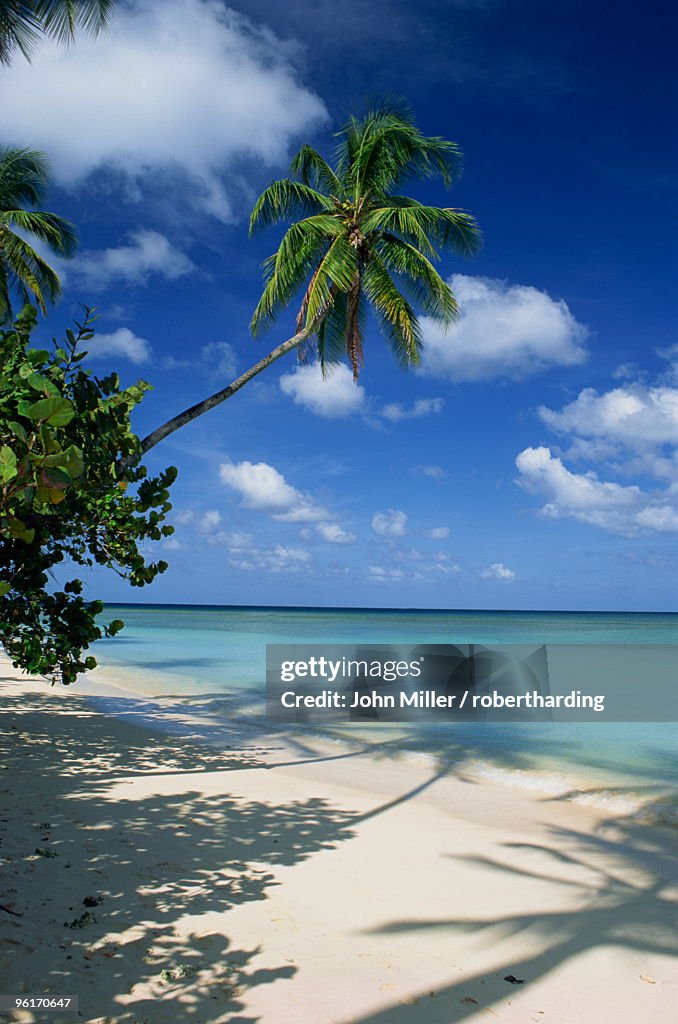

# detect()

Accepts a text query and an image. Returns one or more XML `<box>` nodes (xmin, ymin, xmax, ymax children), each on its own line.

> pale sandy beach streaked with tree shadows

<box><xmin>0</xmin><ymin>660</ymin><xmax>678</xmax><ymax>1024</ymax></box>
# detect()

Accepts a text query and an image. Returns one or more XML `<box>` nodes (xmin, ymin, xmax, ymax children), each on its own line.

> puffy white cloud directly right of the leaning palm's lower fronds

<box><xmin>422</xmin><ymin>273</ymin><xmax>587</xmax><ymax>381</ymax></box>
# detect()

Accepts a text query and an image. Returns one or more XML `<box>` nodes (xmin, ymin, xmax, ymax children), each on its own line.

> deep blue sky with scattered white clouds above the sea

<box><xmin>0</xmin><ymin>0</ymin><xmax>678</xmax><ymax>610</ymax></box>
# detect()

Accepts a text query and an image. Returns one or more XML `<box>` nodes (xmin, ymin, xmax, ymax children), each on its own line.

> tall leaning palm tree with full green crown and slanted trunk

<box><xmin>142</xmin><ymin>102</ymin><xmax>480</xmax><ymax>452</ymax></box>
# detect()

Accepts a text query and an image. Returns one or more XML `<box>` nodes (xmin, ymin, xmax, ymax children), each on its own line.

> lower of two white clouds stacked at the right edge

<box><xmin>515</xmin><ymin>446</ymin><xmax>678</xmax><ymax>536</ymax></box>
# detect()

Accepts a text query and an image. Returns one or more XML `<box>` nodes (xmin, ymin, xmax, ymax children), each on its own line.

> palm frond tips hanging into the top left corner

<box><xmin>0</xmin><ymin>0</ymin><xmax>116</xmax><ymax>65</ymax></box>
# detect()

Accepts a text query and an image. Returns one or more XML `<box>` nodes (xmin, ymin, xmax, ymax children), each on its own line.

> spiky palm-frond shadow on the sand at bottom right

<box><xmin>355</xmin><ymin>801</ymin><xmax>678</xmax><ymax>1024</ymax></box>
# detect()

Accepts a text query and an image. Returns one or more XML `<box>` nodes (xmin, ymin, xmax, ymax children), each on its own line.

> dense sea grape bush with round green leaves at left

<box><xmin>0</xmin><ymin>306</ymin><xmax>176</xmax><ymax>683</ymax></box>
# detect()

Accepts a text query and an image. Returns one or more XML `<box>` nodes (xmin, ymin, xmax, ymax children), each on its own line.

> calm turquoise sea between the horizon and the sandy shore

<box><xmin>94</xmin><ymin>604</ymin><xmax>678</xmax><ymax>821</ymax></box>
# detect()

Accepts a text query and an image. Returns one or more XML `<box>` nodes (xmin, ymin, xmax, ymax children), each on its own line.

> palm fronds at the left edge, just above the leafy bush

<box><xmin>0</xmin><ymin>146</ymin><xmax>77</xmax><ymax>324</ymax></box>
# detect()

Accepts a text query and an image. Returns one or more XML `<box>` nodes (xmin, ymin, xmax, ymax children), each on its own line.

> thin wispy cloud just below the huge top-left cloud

<box><xmin>64</xmin><ymin>229</ymin><xmax>197</xmax><ymax>291</ymax></box>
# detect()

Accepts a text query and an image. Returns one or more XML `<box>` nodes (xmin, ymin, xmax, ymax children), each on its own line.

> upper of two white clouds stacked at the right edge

<box><xmin>539</xmin><ymin>385</ymin><xmax>678</xmax><ymax>447</ymax></box>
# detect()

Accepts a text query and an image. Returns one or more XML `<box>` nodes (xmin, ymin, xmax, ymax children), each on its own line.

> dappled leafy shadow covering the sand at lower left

<box><xmin>0</xmin><ymin>691</ymin><xmax>354</xmax><ymax>1024</ymax></box>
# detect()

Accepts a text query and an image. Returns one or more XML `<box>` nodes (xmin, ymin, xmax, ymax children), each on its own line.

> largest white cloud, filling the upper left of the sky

<box><xmin>0</xmin><ymin>0</ymin><xmax>326</xmax><ymax>220</ymax></box>
